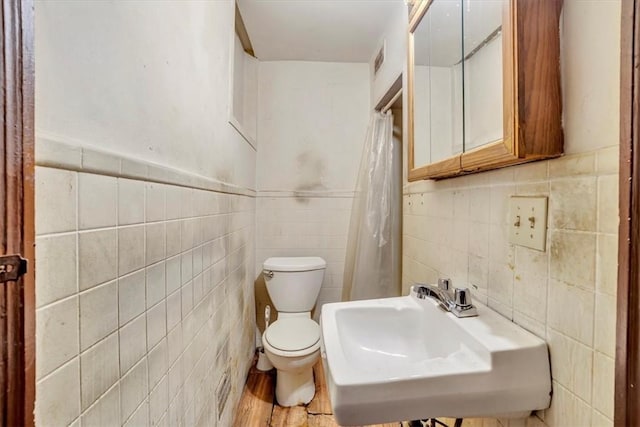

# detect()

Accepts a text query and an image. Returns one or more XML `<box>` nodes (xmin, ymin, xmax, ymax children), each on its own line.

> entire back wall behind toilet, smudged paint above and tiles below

<box><xmin>256</xmin><ymin>61</ymin><xmax>370</xmax><ymax>314</ymax></box>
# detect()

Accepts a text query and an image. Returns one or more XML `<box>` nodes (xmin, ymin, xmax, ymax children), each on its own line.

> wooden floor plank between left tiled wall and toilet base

<box><xmin>233</xmin><ymin>364</ymin><xmax>275</xmax><ymax>427</ymax></box>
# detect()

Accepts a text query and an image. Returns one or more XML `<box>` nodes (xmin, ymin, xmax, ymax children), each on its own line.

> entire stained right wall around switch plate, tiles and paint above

<box><xmin>403</xmin><ymin>0</ymin><xmax>620</xmax><ymax>426</ymax></box>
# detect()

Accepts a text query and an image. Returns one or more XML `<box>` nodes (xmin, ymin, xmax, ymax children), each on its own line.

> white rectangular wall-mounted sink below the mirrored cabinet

<box><xmin>321</xmin><ymin>293</ymin><xmax>551</xmax><ymax>425</ymax></box>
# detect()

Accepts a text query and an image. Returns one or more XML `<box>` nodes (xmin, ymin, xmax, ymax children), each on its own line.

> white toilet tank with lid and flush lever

<box><xmin>262</xmin><ymin>257</ymin><xmax>327</xmax><ymax>313</ymax></box>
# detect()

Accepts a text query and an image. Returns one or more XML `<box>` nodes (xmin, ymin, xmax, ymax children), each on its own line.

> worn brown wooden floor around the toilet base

<box><xmin>233</xmin><ymin>360</ymin><xmax>400</xmax><ymax>427</ymax></box>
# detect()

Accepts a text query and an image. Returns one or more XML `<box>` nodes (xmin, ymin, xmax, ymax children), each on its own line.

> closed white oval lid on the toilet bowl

<box><xmin>264</xmin><ymin>318</ymin><xmax>320</xmax><ymax>351</ymax></box>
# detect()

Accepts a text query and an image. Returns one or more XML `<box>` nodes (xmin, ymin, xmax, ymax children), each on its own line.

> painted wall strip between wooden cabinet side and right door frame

<box><xmin>560</xmin><ymin>0</ymin><xmax>625</xmax><ymax>154</ymax></box>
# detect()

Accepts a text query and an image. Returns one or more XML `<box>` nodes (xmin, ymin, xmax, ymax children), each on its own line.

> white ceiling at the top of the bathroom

<box><xmin>238</xmin><ymin>0</ymin><xmax>407</xmax><ymax>62</ymax></box>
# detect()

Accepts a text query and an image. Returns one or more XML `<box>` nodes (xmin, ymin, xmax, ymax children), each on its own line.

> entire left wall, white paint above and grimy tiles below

<box><xmin>36</xmin><ymin>1</ymin><xmax>255</xmax><ymax>426</ymax></box>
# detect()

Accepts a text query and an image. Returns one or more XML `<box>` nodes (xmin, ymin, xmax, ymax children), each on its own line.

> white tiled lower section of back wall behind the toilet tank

<box><xmin>255</xmin><ymin>197</ymin><xmax>353</xmax><ymax>317</ymax></box>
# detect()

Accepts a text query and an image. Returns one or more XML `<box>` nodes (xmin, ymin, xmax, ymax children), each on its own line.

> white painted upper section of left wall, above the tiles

<box><xmin>36</xmin><ymin>1</ymin><xmax>255</xmax><ymax>188</ymax></box>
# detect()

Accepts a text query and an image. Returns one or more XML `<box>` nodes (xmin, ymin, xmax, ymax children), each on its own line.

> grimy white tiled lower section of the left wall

<box><xmin>36</xmin><ymin>166</ymin><xmax>255</xmax><ymax>426</ymax></box>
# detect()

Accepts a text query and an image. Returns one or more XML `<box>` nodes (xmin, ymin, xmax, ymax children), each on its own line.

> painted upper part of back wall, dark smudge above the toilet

<box><xmin>257</xmin><ymin>61</ymin><xmax>370</xmax><ymax>191</ymax></box>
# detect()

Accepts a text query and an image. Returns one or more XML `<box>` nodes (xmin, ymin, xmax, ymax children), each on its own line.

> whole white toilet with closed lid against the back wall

<box><xmin>262</xmin><ymin>257</ymin><xmax>327</xmax><ymax>406</ymax></box>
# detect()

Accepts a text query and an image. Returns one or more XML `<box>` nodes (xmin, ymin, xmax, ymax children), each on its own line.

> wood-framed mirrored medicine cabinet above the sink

<box><xmin>407</xmin><ymin>0</ymin><xmax>563</xmax><ymax>181</ymax></box>
